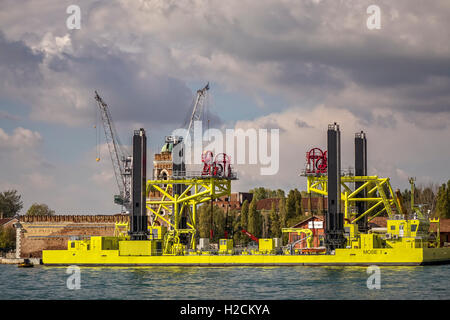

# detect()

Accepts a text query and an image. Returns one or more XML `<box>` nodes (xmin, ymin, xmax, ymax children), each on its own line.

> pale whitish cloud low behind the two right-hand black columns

<box><xmin>230</xmin><ymin>105</ymin><xmax>450</xmax><ymax>191</ymax></box>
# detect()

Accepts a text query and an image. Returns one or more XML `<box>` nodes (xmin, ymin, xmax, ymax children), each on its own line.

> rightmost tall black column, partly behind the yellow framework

<box><xmin>355</xmin><ymin>131</ymin><xmax>368</xmax><ymax>232</ymax></box>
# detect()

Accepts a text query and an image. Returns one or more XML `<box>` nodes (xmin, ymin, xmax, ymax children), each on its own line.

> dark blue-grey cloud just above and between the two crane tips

<box><xmin>60</xmin><ymin>47</ymin><xmax>192</xmax><ymax>124</ymax></box>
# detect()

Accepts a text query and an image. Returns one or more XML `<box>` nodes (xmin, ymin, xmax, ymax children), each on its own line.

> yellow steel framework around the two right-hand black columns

<box><xmin>307</xmin><ymin>176</ymin><xmax>401</xmax><ymax>223</ymax></box>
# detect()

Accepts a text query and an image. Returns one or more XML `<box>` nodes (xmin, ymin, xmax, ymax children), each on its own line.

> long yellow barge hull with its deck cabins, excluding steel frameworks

<box><xmin>42</xmin><ymin>219</ymin><xmax>450</xmax><ymax>266</ymax></box>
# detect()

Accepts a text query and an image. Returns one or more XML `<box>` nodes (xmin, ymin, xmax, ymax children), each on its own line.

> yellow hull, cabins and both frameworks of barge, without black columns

<box><xmin>42</xmin><ymin>172</ymin><xmax>450</xmax><ymax>266</ymax></box>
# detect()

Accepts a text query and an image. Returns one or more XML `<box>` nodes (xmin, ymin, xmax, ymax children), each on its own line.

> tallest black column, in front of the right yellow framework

<box><xmin>325</xmin><ymin>122</ymin><xmax>345</xmax><ymax>251</ymax></box>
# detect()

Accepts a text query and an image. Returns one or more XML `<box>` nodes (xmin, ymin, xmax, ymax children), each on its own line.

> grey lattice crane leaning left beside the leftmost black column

<box><xmin>95</xmin><ymin>91</ymin><xmax>132</xmax><ymax>212</ymax></box>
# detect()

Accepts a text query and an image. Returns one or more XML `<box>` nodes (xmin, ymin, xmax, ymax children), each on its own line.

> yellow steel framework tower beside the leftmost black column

<box><xmin>147</xmin><ymin>177</ymin><xmax>231</xmax><ymax>255</ymax></box>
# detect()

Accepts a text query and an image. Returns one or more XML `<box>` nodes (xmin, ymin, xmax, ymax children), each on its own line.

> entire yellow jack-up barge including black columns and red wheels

<box><xmin>42</xmin><ymin>123</ymin><xmax>450</xmax><ymax>266</ymax></box>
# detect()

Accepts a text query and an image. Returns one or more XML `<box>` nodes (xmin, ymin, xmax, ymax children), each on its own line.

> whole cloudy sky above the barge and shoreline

<box><xmin>0</xmin><ymin>0</ymin><xmax>450</xmax><ymax>214</ymax></box>
